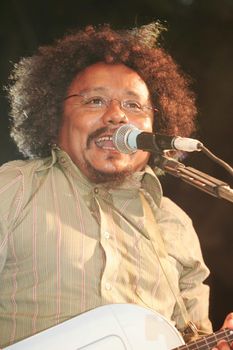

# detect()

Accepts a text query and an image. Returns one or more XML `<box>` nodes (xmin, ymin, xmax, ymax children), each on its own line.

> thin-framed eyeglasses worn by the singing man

<box><xmin>64</xmin><ymin>94</ymin><xmax>158</xmax><ymax>115</ymax></box>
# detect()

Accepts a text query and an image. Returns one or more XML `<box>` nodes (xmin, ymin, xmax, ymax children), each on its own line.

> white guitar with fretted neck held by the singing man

<box><xmin>4</xmin><ymin>304</ymin><xmax>233</xmax><ymax>350</ymax></box>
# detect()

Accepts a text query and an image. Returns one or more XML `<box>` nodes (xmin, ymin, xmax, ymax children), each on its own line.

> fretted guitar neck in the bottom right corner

<box><xmin>177</xmin><ymin>329</ymin><xmax>233</xmax><ymax>350</ymax></box>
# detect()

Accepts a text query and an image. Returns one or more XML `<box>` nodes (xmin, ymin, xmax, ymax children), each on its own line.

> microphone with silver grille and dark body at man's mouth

<box><xmin>112</xmin><ymin>124</ymin><xmax>203</xmax><ymax>154</ymax></box>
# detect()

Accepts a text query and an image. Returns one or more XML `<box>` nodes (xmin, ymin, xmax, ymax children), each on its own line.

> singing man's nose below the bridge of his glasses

<box><xmin>102</xmin><ymin>100</ymin><xmax>129</xmax><ymax>125</ymax></box>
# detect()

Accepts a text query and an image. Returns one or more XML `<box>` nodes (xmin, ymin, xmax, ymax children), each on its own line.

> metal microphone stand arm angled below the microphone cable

<box><xmin>156</xmin><ymin>156</ymin><xmax>233</xmax><ymax>203</ymax></box>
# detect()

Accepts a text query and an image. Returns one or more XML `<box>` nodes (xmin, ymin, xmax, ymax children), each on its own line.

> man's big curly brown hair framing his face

<box><xmin>8</xmin><ymin>23</ymin><xmax>196</xmax><ymax>157</ymax></box>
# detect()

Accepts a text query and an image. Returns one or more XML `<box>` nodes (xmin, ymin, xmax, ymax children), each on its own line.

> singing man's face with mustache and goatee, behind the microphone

<box><xmin>59</xmin><ymin>63</ymin><xmax>153</xmax><ymax>182</ymax></box>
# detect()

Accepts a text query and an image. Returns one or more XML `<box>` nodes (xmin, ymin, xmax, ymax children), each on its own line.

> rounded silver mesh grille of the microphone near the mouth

<box><xmin>112</xmin><ymin>124</ymin><xmax>137</xmax><ymax>154</ymax></box>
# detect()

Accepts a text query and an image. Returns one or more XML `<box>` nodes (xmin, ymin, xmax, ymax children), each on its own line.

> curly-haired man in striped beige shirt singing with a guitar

<box><xmin>0</xmin><ymin>24</ymin><xmax>233</xmax><ymax>349</ymax></box>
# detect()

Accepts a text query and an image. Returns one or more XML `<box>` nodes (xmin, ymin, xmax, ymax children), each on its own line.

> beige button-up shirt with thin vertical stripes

<box><xmin>0</xmin><ymin>149</ymin><xmax>211</xmax><ymax>347</ymax></box>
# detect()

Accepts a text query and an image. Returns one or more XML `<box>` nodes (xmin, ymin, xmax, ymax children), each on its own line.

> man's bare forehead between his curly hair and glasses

<box><xmin>68</xmin><ymin>62</ymin><xmax>149</xmax><ymax>100</ymax></box>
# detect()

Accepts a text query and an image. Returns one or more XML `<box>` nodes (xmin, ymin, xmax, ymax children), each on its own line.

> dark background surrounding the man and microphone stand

<box><xmin>0</xmin><ymin>0</ymin><xmax>233</xmax><ymax>329</ymax></box>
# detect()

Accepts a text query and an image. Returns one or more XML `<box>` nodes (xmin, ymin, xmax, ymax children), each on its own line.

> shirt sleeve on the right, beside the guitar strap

<box><xmin>158</xmin><ymin>198</ymin><xmax>212</xmax><ymax>334</ymax></box>
